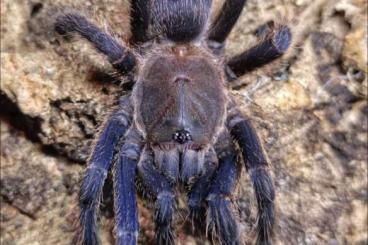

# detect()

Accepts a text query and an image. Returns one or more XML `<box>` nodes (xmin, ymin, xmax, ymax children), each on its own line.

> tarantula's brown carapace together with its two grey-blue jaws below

<box><xmin>133</xmin><ymin>44</ymin><xmax>226</xmax><ymax>184</ymax></box>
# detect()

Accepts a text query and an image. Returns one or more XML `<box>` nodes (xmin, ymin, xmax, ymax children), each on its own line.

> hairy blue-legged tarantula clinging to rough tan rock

<box><xmin>55</xmin><ymin>0</ymin><xmax>291</xmax><ymax>245</ymax></box>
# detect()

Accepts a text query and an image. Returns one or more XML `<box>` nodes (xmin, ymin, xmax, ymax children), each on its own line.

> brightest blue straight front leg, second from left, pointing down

<box><xmin>114</xmin><ymin>128</ymin><xmax>141</xmax><ymax>245</ymax></box>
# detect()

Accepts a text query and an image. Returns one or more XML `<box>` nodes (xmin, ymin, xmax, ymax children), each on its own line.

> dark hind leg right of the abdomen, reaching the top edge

<box><xmin>208</xmin><ymin>0</ymin><xmax>246</xmax><ymax>50</ymax></box>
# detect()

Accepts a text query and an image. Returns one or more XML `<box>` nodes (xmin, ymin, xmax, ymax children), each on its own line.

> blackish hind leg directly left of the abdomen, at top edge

<box><xmin>130</xmin><ymin>0</ymin><xmax>151</xmax><ymax>44</ymax></box>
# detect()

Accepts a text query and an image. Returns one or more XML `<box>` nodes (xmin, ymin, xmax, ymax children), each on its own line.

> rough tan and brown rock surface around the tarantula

<box><xmin>0</xmin><ymin>0</ymin><xmax>368</xmax><ymax>245</ymax></box>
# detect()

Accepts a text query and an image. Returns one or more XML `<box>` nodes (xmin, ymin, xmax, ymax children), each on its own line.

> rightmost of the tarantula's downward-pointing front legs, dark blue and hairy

<box><xmin>228</xmin><ymin>116</ymin><xmax>275</xmax><ymax>244</ymax></box>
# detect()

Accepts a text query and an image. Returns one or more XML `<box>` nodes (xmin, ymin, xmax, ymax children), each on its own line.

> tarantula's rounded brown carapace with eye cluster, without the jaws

<box><xmin>136</xmin><ymin>45</ymin><xmax>226</xmax><ymax>147</ymax></box>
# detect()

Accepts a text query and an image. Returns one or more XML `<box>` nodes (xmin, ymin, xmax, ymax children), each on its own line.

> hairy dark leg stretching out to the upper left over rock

<box><xmin>55</xmin><ymin>12</ymin><xmax>136</xmax><ymax>74</ymax></box>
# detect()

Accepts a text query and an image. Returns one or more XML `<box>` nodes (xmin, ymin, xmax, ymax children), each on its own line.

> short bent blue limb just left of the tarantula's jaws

<box><xmin>138</xmin><ymin>149</ymin><xmax>176</xmax><ymax>245</ymax></box>
